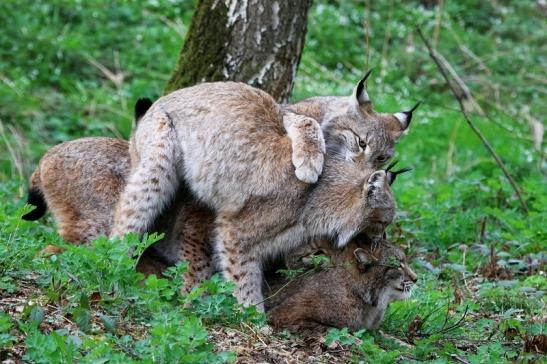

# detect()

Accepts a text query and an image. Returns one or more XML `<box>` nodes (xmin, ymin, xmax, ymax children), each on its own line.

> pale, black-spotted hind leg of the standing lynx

<box><xmin>110</xmin><ymin>110</ymin><xmax>180</xmax><ymax>237</ymax></box>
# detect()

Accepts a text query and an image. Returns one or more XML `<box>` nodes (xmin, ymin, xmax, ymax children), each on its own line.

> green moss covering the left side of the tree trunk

<box><xmin>165</xmin><ymin>0</ymin><xmax>231</xmax><ymax>93</ymax></box>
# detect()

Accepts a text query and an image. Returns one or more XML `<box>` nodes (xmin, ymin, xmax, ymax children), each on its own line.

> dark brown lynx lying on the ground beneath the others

<box><xmin>268</xmin><ymin>235</ymin><xmax>417</xmax><ymax>331</ymax></box>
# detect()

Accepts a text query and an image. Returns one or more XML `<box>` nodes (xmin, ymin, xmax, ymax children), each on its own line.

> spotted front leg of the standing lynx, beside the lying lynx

<box><xmin>214</xmin><ymin>222</ymin><xmax>264</xmax><ymax>312</ymax></box>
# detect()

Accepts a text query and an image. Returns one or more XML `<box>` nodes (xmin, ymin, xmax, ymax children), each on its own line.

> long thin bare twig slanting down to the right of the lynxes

<box><xmin>417</xmin><ymin>28</ymin><xmax>528</xmax><ymax>213</ymax></box>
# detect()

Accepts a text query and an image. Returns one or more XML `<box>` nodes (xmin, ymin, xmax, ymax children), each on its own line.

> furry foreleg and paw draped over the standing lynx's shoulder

<box><xmin>283</xmin><ymin>112</ymin><xmax>325</xmax><ymax>183</ymax></box>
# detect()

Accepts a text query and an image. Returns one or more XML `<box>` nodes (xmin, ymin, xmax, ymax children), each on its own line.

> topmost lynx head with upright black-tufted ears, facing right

<box><xmin>323</xmin><ymin>71</ymin><xmax>420</xmax><ymax>169</ymax></box>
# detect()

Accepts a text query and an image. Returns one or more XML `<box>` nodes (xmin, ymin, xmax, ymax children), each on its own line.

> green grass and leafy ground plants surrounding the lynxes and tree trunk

<box><xmin>0</xmin><ymin>0</ymin><xmax>547</xmax><ymax>363</ymax></box>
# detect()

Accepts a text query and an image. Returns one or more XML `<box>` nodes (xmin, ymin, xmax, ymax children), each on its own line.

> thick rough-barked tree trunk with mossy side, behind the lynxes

<box><xmin>165</xmin><ymin>0</ymin><xmax>312</xmax><ymax>102</ymax></box>
